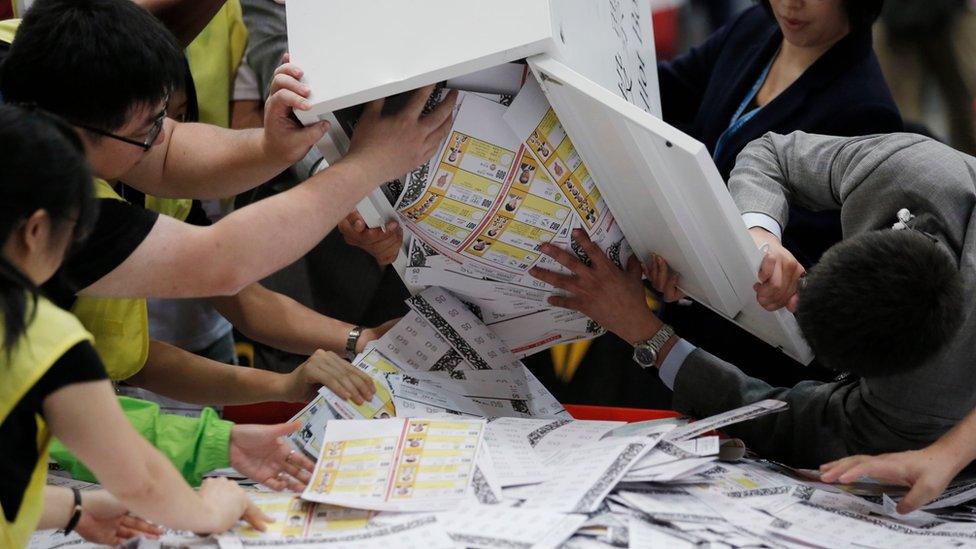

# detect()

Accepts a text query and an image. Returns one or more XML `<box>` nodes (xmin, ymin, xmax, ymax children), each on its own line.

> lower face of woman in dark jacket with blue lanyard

<box><xmin>769</xmin><ymin>0</ymin><xmax>850</xmax><ymax>48</ymax></box>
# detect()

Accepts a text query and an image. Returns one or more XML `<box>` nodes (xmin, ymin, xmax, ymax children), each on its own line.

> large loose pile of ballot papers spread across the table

<box><xmin>31</xmin><ymin>394</ymin><xmax>976</xmax><ymax>549</ymax></box>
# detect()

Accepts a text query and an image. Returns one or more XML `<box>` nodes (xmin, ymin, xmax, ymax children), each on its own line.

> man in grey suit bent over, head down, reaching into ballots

<box><xmin>533</xmin><ymin>128</ymin><xmax>976</xmax><ymax>467</ymax></box>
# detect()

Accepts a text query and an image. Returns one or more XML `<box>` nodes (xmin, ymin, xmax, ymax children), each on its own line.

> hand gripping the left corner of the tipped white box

<box><xmin>263</xmin><ymin>53</ymin><xmax>329</xmax><ymax>164</ymax></box>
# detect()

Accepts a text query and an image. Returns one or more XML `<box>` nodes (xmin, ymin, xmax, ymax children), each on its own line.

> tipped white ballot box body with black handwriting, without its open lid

<box><xmin>286</xmin><ymin>0</ymin><xmax>661</xmax><ymax>123</ymax></box>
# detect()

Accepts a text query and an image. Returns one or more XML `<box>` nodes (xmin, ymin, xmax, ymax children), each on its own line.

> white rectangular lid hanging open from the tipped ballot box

<box><xmin>529</xmin><ymin>55</ymin><xmax>812</xmax><ymax>364</ymax></box>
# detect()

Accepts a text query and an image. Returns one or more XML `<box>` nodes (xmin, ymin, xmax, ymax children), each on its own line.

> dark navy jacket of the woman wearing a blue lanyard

<box><xmin>658</xmin><ymin>6</ymin><xmax>903</xmax><ymax>179</ymax></box>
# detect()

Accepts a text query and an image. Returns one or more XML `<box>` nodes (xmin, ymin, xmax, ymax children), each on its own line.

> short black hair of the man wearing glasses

<box><xmin>0</xmin><ymin>0</ymin><xmax>183</xmax><ymax>131</ymax></box>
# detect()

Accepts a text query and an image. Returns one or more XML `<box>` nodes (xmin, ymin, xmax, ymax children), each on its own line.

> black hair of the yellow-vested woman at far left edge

<box><xmin>0</xmin><ymin>105</ymin><xmax>97</xmax><ymax>352</ymax></box>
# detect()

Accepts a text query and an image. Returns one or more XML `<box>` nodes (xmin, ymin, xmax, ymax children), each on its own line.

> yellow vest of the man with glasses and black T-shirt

<box><xmin>71</xmin><ymin>179</ymin><xmax>149</xmax><ymax>381</ymax></box>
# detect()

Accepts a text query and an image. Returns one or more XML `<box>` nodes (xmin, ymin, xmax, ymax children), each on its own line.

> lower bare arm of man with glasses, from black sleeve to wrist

<box><xmin>82</xmin><ymin>160</ymin><xmax>382</xmax><ymax>298</ymax></box>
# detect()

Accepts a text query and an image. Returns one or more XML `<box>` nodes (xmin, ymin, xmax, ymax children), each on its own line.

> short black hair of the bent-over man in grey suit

<box><xmin>796</xmin><ymin>230</ymin><xmax>963</xmax><ymax>377</ymax></box>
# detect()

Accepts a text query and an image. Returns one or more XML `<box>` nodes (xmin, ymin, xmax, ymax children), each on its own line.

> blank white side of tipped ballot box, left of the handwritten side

<box><xmin>286</xmin><ymin>0</ymin><xmax>553</xmax><ymax>121</ymax></box>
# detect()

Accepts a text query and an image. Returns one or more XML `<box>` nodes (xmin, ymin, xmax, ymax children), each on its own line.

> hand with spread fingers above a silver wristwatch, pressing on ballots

<box><xmin>529</xmin><ymin>230</ymin><xmax>662</xmax><ymax>343</ymax></box>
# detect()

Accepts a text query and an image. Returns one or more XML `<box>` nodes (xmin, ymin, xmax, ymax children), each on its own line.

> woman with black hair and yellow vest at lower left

<box><xmin>0</xmin><ymin>107</ymin><xmax>268</xmax><ymax>548</ymax></box>
